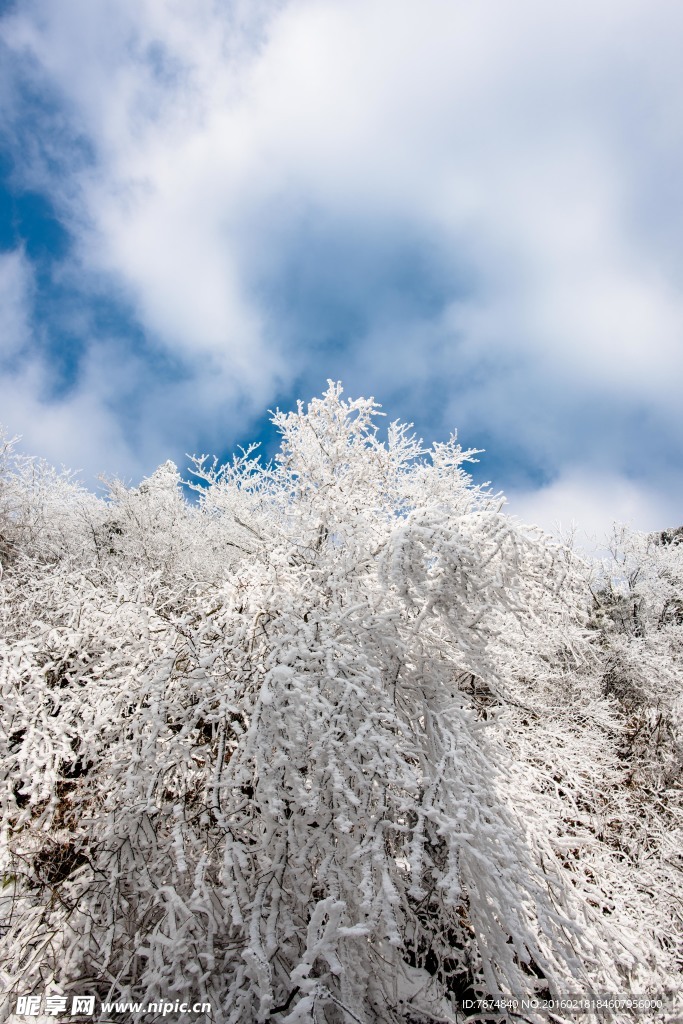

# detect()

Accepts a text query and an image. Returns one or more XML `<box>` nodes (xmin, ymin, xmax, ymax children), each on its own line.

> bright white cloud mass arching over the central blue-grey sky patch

<box><xmin>3</xmin><ymin>0</ymin><xmax>683</xmax><ymax>385</ymax></box>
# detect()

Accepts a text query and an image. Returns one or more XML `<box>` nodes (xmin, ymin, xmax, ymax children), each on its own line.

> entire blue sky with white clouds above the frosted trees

<box><xmin>0</xmin><ymin>0</ymin><xmax>683</xmax><ymax>544</ymax></box>
